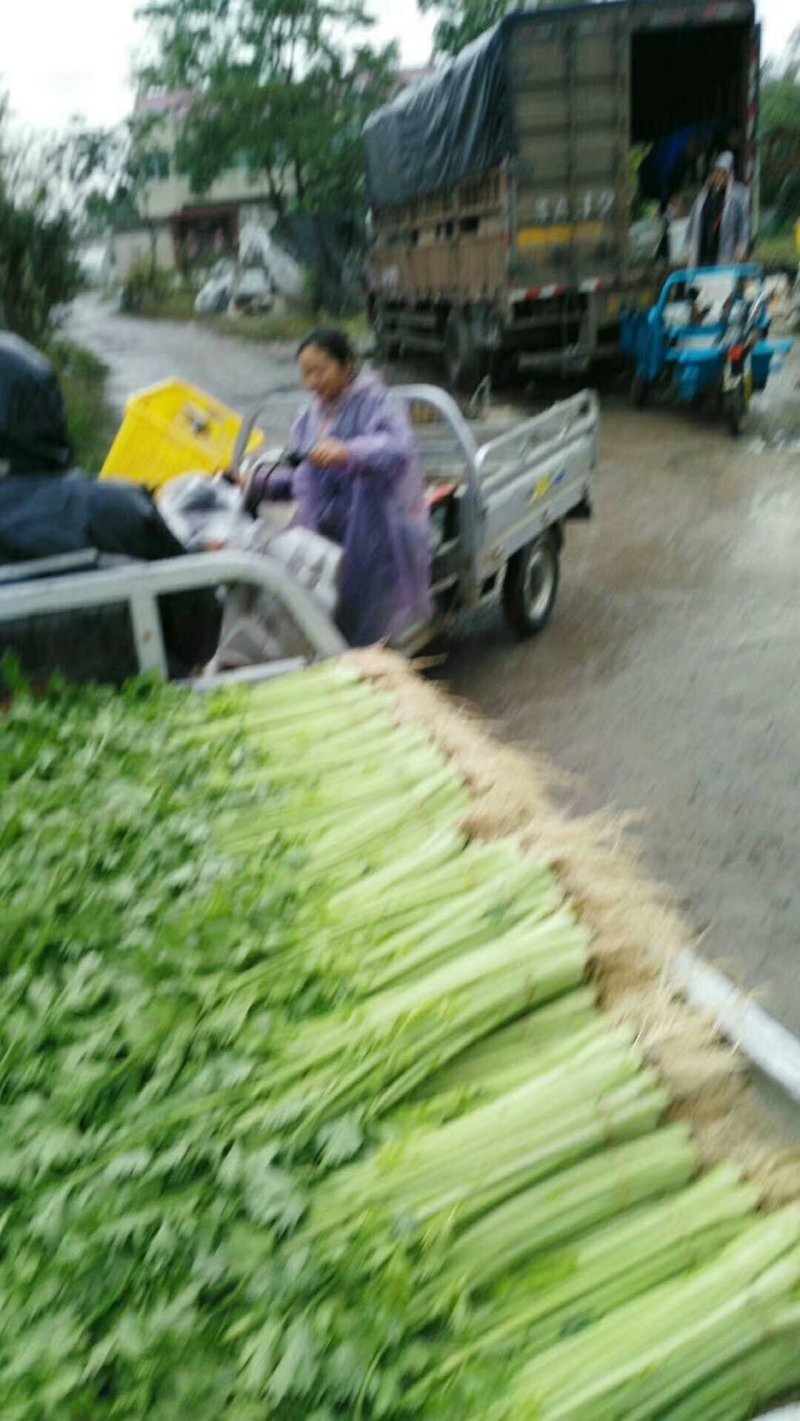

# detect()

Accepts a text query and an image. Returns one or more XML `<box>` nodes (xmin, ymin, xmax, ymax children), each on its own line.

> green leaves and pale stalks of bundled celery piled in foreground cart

<box><xmin>0</xmin><ymin>666</ymin><xmax>800</xmax><ymax>1421</ymax></box>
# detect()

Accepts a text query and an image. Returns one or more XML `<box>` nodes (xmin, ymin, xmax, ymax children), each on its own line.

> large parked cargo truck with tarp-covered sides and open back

<box><xmin>364</xmin><ymin>0</ymin><xmax>759</xmax><ymax>387</ymax></box>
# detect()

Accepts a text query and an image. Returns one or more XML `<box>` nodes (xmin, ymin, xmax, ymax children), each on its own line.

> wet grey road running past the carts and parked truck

<box><xmin>71</xmin><ymin>298</ymin><xmax>800</xmax><ymax>1032</ymax></box>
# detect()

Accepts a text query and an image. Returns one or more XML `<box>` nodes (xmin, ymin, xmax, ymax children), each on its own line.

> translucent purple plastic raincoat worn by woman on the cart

<box><xmin>291</xmin><ymin>374</ymin><xmax>431</xmax><ymax>647</ymax></box>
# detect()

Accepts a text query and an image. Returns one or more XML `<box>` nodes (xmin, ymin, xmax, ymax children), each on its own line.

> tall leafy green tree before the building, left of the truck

<box><xmin>142</xmin><ymin>0</ymin><xmax>396</xmax><ymax>213</ymax></box>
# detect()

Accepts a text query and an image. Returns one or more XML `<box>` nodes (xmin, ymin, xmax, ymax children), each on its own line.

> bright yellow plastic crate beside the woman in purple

<box><xmin>101</xmin><ymin>379</ymin><xmax>264</xmax><ymax>489</ymax></box>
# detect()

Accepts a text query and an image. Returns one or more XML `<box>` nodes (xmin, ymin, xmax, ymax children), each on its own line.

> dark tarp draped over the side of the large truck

<box><xmin>364</xmin><ymin>17</ymin><xmax>513</xmax><ymax>209</ymax></box>
